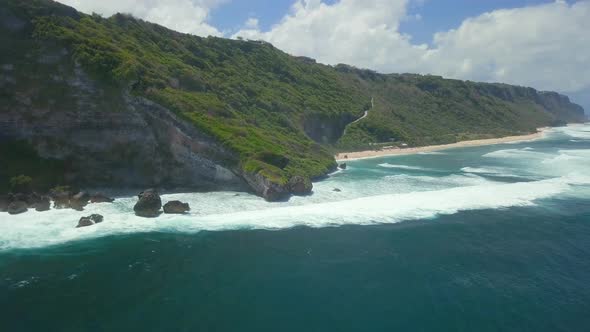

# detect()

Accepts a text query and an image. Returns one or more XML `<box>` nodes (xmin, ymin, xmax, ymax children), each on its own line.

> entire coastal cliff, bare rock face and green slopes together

<box><xmin>0</xmin><ymin>0</ymin><xmax>583</xmax><ymax>200</ymax></box>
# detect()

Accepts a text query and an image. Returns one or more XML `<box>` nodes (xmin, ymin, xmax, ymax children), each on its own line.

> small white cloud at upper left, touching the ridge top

<box><xmin>58</xmin><ymin>0</ymin><xmax>226</xmax><ymax>36</ymax></box>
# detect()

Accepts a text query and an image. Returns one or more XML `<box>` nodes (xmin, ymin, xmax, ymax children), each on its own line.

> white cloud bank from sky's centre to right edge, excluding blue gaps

<box><xmin>234</xmin><ymin>0</ymin><xmax>590</xmax><ymax>96</ymax></box>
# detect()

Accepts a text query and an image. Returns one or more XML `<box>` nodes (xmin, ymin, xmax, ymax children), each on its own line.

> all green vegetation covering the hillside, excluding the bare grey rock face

<box><xmin>0</xmin><ymin>0</ymin><xmax>577</xmax><ymax>197</ymax></box>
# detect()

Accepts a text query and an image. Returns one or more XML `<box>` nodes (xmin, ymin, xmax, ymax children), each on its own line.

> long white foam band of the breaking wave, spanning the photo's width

<box><xmin>0</xmin><ymin>176</ymin><xmax>590</xmax><ymax>250</ymax></box>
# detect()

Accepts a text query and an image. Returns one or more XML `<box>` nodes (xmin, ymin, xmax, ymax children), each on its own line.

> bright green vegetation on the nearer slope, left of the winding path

<box><xmin>19</xmin><ymin>2</ymin><xmax>367</xmax><ymax>181</ymax></box>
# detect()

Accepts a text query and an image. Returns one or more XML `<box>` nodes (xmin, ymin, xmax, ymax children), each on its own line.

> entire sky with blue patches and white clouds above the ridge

<box><xmin>58</xmin><ymin>0</ymin><xmax>590</xmax><ymax>109</ymax></box>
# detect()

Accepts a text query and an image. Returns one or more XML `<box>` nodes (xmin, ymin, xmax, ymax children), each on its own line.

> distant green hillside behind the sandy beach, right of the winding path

<box><xmin>337</xmin><ymin>65</ymin><xmax>580</xmax><ymax>150</ymax></box>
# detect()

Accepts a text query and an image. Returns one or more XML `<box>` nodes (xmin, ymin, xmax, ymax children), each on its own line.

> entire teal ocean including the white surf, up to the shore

<box><xmin>0</xmin><ymin>125</ymin><xmax>590</xmax><ymax>332</ymax></box>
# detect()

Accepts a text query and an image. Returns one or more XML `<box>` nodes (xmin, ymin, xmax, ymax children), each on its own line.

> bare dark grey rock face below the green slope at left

<box><xmin>0</xmin><ymin>45</ymin><xmax>247</xmax><ymax>190</ymax></box>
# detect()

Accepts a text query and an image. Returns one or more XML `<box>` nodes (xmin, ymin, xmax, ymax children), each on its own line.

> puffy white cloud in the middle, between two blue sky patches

<box><xmin>234</xmin><ymin>0</ymin><xmax>426</xmax><ymax>71</ymax></box>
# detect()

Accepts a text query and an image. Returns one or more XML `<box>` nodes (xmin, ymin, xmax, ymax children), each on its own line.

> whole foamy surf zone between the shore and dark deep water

<box><xmin>0</xmin><ymin>126</ymin><xmax>590</xmax><ymax>250</ymax></box>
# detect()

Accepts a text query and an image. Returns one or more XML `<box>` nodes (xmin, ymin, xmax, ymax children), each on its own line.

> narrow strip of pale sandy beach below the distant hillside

<box><xmin>334</xmin><ymin>127</ymin><xmax>550</xmax><ymax>162</ymax></box>
